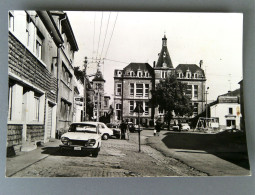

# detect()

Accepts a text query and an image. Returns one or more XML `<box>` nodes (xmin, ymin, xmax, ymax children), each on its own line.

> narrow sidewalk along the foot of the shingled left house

<box><xmin>5</xmin><ymin>139</ymin><xmax>60</xmax><ymax>177</ymax></box>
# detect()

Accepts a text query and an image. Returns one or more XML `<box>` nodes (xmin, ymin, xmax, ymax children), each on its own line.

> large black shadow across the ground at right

<box><xmin>162</xmin><ymin>132</ymin><xmax>250</xmax><ymax>169</ymax></box>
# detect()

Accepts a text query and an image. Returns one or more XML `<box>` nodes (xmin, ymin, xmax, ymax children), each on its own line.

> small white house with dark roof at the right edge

<box><xmin>210</xmin><ymin>89</ymin><xmax>241</xmax><ymax>129</ymax></box>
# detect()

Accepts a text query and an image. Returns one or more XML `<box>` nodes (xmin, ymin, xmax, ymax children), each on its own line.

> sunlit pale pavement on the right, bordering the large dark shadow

<box><xmin>147</xmin><ymin>135</ymin><xmax>250</xmax><ymax>176</ymax></box>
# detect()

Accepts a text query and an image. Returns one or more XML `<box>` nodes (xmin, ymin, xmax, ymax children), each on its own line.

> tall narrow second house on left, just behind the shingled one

<box><xmin>50</xmin><ymin>11</ymin><xmax>79</xmax><ymax>133</ymax></box>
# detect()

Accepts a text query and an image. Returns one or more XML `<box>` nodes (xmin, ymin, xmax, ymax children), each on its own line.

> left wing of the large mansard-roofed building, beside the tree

<box><xmin>114</xmin><ymin>63</ymin><xmax>155</xmax><ymax>125</ymax></box>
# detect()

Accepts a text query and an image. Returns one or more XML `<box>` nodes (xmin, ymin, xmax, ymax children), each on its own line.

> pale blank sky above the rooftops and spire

<box><xmin>66</xmin><ymin>11</ymin><xmax>243</xmax><ymax>100</ymax></box>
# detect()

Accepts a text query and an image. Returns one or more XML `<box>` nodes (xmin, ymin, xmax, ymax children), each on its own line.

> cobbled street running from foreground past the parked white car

<box><xmin>7</xmin><ymin>130</ymin><xmax>207</xmax><ymax>177</ymax></box>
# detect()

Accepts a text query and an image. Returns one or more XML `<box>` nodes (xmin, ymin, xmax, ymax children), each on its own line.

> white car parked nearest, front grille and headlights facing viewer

<box><xmin>59</xmin><ymin>122</ymin><xmax>101</xmax><ymax>157</ymax></box>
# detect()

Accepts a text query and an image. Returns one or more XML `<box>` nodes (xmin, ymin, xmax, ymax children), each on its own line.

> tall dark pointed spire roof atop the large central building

<box><xmin>156</xmin><ymin>36</ymin><xmax>174</xmax><ymax>68</ymax></box>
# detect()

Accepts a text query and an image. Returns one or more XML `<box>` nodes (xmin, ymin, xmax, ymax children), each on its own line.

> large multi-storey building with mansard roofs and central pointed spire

<box><xmin>114</xmin><ymin>35</ymin><xmax>206</xmax><ymax>125</ymax></box>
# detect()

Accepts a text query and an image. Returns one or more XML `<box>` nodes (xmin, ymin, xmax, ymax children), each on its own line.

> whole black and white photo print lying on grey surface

<box><xmin>6</xmin><ymin>10</ymin><xmax>251</xmax><ymax>178</ymax></box>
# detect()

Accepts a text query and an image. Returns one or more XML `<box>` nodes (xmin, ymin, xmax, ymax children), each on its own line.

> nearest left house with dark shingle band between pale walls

<box><xmin>7</xmin><ymin>11</ymin><xmax>63</xmax><ymax>155</ymax></box>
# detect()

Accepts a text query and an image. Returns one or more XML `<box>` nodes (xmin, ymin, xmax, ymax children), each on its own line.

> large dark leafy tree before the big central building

<box><xmin>151</xmin><ymin>74</ymin><xmax>193</xmax><ymax>129</ymax></box>
